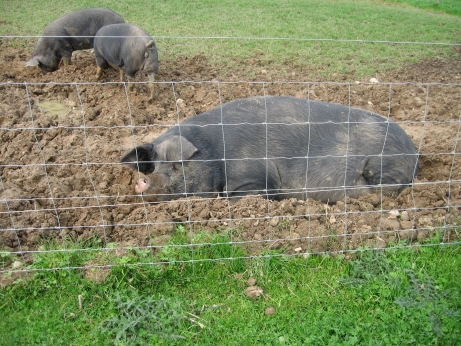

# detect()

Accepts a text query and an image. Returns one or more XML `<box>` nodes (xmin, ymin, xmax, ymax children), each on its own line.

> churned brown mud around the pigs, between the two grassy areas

<box><xmin>0</xmin><ymin>41</ymin><xmax>461</xmax><ymax>269</ymax></box>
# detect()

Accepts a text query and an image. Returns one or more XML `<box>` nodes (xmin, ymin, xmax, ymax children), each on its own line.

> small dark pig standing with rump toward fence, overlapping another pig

<box><xmin>94</xmin><ymin>24</ymin><xmax>158</xmax><ymax>99</ymax></box>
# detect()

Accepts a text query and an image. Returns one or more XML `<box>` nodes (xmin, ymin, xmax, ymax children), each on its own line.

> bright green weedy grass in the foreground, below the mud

<box><xmin>0</xmin><ymin>227</ymin><xmax>461</xmax><ymax>345</ymax></box>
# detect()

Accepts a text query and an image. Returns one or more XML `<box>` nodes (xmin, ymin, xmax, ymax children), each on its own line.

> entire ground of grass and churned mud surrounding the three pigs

<box><xmin>0</xmin><ymin>0</ymin><xmax>461</xmax><ymax>345</ymax></box>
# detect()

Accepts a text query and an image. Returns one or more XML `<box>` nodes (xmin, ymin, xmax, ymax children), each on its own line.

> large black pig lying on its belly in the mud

<box><xmin>121</xmin><ymin>96</ymin><xmax>418</xmax><ymax>203</ymax></box>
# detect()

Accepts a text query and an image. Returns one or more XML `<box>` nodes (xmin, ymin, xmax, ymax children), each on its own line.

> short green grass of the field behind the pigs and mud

<box><xmin>0</xmin><ymin>0</ymin><xmax>461</xmax><ymax>79</ymax></box>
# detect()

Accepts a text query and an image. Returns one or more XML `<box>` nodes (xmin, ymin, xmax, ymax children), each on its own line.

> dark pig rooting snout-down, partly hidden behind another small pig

<box><xmin>26</xmin><ymin>8</ymin><xmax>125</xmax><ymax>73</ymax></box>
